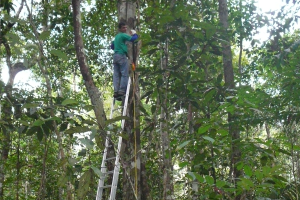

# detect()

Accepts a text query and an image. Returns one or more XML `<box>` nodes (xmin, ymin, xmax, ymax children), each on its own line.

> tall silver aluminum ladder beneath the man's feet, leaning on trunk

<box><xmin>96</xmin><ymin>77</ymin><xmax>131</xmax><ymax>200</ymax></box>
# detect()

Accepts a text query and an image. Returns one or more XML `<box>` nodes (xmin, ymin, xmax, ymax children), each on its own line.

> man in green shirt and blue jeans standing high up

<box><xmin>111</xmin><ymin>22</ymin><xmax>138</xmax><ymax>101</ymax></box>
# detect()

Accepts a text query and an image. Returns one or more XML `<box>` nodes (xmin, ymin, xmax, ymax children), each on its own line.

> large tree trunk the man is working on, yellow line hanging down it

<box><xmin>118</xmin><ymin>0</ymin><xmax>142</xmax><ymax>200</ymax></box>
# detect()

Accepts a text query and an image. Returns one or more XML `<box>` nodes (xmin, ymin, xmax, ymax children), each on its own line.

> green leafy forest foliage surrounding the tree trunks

<box><xmin>0</xmin><ymin>0</ymin><xmax>300</xmax><ymax>199</ymax></box>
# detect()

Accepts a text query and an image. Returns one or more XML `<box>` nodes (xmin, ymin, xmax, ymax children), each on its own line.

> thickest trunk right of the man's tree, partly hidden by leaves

<box><xmin>219</xmin><ymin>0</ymin><xmax>242</xmax><ymax>200</ymax></box>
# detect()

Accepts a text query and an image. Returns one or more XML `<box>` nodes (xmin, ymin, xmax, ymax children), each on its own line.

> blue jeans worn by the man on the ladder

<box><xmin>113</xmin><ymin>54</ymin><xmax>129</xmax><ymax>93</ymax></box>
